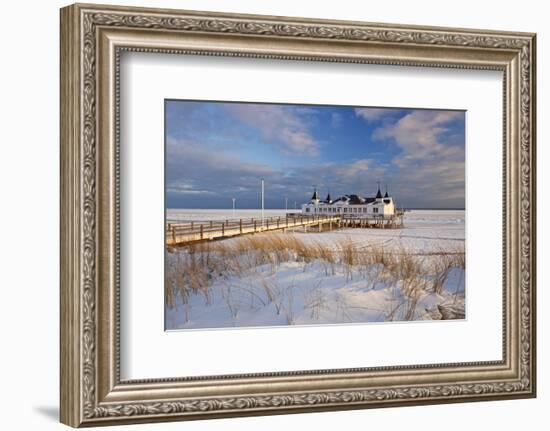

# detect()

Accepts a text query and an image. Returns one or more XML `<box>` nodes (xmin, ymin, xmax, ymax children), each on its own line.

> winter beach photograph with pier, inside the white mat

<box><xmin>164</xmin><ymin>99</ymin><xmax>468</xmax><ymax>330</ymax></box>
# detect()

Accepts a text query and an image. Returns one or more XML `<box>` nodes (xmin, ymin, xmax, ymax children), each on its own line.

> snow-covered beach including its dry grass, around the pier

<box><xmin>165</xmin><ymin>209</ymin><xmax>465</xmax><ymax>330</ymax></box>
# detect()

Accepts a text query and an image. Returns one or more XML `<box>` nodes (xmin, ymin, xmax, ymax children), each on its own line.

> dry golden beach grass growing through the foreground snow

<box><xmin>165</xmin><ymin>233</ymin><xmax>465</xmax><ymax>324</ymax></box>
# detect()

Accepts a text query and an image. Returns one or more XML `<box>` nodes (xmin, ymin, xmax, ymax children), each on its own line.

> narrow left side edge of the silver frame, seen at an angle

<box><xmin>59</xmin><ymin>5</ymin><xmax>83</xmax><ymax>427</ymax></box>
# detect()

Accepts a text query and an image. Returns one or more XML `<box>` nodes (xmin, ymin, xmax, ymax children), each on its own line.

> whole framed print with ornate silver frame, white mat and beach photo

<box><xmin>61</xmin><ymin>5</ymin><xmax>536</xmax><ymax>426</ymax></box>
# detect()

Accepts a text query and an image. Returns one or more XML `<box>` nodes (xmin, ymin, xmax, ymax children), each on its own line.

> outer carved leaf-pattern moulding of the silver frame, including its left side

<box><xmin>60</xmin><ymin>5</ymin><xmax>536</xmax><ymax>426</ymax></box>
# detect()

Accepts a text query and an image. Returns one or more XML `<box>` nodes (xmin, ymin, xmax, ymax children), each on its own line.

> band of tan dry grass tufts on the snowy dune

<box><xmin>164</xmin><ymin>233</ymin><xmax>466</xmax><ymax>324</ymax></box>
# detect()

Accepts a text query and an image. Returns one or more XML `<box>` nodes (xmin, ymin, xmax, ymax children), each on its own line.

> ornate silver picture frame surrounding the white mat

<box><xmin>60</xmin><ymin>4</ymin><xmax>536</xmax><ymax>427</ymax></box>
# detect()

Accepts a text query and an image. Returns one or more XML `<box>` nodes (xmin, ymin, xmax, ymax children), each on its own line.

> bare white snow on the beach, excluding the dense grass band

<box><xmin>166</xmin><ymin>209</ymin><xmax>465</xmax><ymax>329</ymax></box>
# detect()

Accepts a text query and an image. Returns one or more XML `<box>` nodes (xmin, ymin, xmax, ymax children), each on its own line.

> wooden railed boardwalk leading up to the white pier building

<box><xmin>166</xmin><ymin>215</ymin><xmax>341</xmax><ymax>245</ymax></box>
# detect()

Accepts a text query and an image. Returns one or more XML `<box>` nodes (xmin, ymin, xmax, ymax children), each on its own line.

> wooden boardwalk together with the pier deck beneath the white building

<box><xmin>166</xmin><ymin>212</ymin><xmax>403</xmax><ymax>246</ymax></box>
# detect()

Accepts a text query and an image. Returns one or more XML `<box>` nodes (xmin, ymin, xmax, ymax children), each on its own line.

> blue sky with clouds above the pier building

<box><xmin>165</xmin><ymin>100</ymin><xmax>465</xmax><ymax>208</ymax></box>
